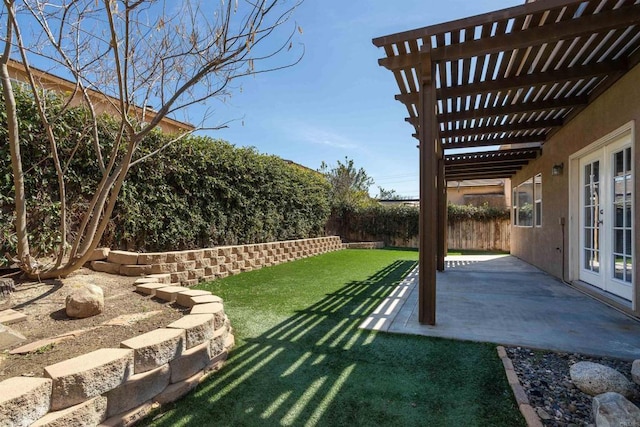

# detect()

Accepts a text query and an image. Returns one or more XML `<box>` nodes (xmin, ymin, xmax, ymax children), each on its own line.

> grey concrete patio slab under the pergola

<box><xmin>361</xmin><ymin>255</ymin><xmax>640</xmax><ymax>359</ymax></box>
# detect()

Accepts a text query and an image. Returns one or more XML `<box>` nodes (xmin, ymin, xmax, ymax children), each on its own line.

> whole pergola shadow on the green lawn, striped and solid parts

<box><xmin>147</xmin><ymin>261</ymin><xmax>523</xmax><ymax>426</ymax></box>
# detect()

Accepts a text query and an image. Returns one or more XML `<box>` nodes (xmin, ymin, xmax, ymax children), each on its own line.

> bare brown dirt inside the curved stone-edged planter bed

<box><xmin>0</xmin><ymin>268</ymin><xmax>187</xmax><ymax>381</ymax></box>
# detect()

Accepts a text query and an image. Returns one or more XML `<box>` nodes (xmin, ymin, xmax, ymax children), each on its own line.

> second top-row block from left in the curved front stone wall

<box><xmin>44</xmin><ymin>348</ymin><xmax>134</xmax><ymax>411</ymax></box>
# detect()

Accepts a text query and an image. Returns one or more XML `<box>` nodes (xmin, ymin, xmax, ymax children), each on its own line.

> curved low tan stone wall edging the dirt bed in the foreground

<box><xmin>0</xmin><ymin>282</ymin><xmax>234</xmax><ymax>427</ymax></box>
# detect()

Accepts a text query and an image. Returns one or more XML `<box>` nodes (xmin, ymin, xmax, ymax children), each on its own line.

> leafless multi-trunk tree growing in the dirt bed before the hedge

<box><xmin>0</xmin><ymin>0</ymin><xmax>303</xmax><ymax>278</ymax></box>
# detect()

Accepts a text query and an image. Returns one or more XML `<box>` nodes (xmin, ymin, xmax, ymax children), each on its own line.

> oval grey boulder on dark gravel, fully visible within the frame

<box><xmin>569</xmin><ymin>362</ymin><xmax>635</xmax><ymax>397</ymax></box>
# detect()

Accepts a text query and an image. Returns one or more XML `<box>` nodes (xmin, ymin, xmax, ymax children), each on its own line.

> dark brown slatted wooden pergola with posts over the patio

<box><xmin>373</xmin><ymin>0</ymin><xmax>640</xmax><ymax>325</ymax></box>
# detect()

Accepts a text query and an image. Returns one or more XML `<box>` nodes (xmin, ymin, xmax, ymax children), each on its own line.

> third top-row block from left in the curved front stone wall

<box><xmin>120</xmin><ymin>328</ymin><xmax>185</xmax><ymax>374</ymax></box>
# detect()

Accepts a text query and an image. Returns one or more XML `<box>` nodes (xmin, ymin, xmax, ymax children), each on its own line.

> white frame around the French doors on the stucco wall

<box><xmin>567</xmin><ymin>121</ymin><xmax>639</xmax><ymax>311</ymax></box>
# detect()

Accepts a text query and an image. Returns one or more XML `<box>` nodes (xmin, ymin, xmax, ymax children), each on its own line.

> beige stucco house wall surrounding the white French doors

<box><xmin>511</xmin><ymin>65</ymin><xmax>640</xmax><ymax>316</ymax></box>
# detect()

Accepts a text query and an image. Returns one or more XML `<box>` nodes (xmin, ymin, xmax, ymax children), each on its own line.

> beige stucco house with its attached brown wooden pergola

<box><xmin>374</xmin><ymin>0</ymin><xmax>640</xmax><ymax>324</ymax></box>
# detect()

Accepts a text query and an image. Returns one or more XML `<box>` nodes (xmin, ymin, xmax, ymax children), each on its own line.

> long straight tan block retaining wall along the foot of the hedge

<box><xmin>90</xmin><ymin>236</ymin><xmax>343</xmax><ymax>286</ymax></box>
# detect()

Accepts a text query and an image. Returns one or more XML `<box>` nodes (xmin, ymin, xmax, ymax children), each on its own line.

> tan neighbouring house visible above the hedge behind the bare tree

<box><xmin>8</xmin><ymin>60</ymin><xmax>195</xmax><ymax>133</ymax></box>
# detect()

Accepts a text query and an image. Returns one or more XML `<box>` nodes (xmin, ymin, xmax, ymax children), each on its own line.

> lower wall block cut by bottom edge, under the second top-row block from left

<box><xmin>31</xmin><ymin>396</ymin><xmax>107</xmax><ymax>427</ymax></box>
